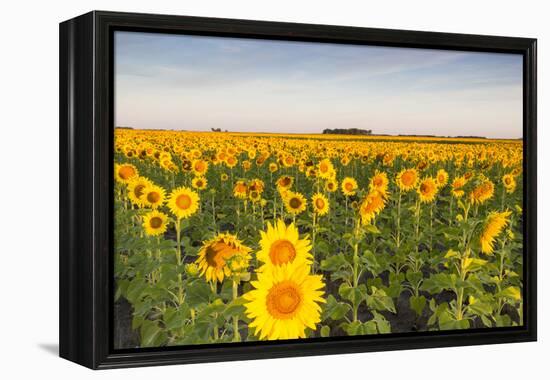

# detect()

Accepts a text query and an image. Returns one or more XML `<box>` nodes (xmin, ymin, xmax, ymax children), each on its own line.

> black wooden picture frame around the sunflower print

<box><xmin>59</xmin><ymin>11</ymin><xmax>537</xmax><ymax>369</ymax></box>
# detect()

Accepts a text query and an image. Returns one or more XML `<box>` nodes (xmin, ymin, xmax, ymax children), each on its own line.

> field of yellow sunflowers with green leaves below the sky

<box><xmin>114</xmin><ymin>128</ymin><xmax>523</xmax><ymax>348</ymax></box>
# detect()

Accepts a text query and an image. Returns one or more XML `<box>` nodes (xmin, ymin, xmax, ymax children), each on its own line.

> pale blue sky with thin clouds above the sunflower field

<box><xmin>115</xmin><ymin>31</ymin><xmax>523</xmax><ymax>138</ymax></box>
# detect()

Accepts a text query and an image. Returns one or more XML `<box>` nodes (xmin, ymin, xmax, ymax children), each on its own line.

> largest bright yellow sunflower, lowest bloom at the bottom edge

<box><xmin>243</xmin><ymin>264</ymin><xmax>325</xmax><ymax>340</ymax></box>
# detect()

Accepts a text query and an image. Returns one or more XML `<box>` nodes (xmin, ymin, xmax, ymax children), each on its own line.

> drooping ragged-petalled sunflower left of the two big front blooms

<box><xmin>195</xmin><ymin>233</ymin><xmax>251</xmax><ymax>282</ymax></box>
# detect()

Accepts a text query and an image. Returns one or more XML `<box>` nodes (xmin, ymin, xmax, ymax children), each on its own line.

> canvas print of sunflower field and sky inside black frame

<box><xmin>113</xmin><ymin>31</ymin><xmax>523</xmax><ymax>349</ymax></box>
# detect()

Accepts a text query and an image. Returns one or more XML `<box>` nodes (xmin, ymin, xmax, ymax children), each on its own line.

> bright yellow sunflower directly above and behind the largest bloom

<box><xmin>256</xmin><ymin>219</ymin><xmax>312</xmax><ymax>266</ymax></box>
